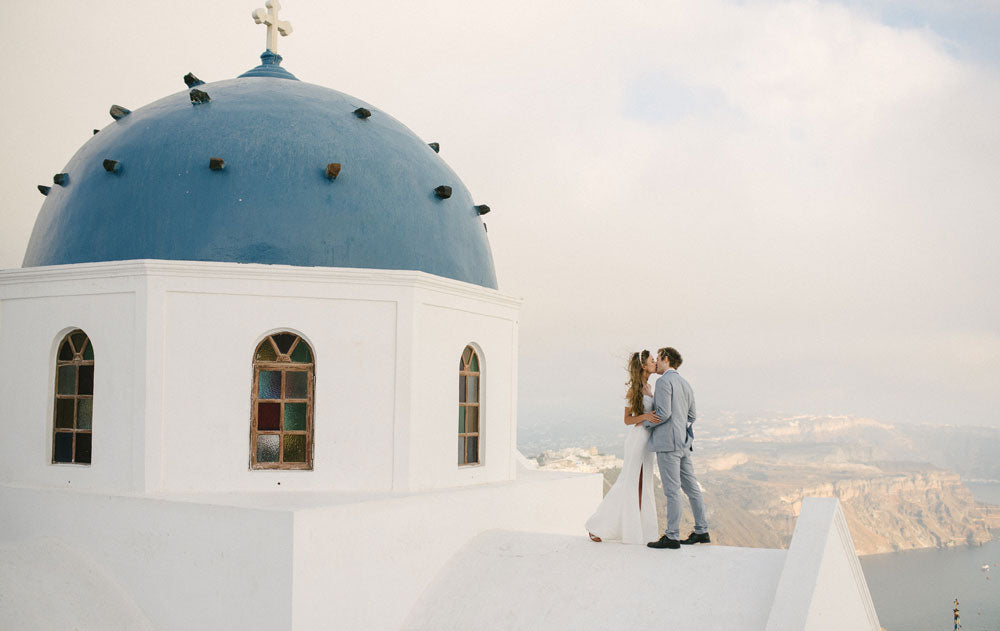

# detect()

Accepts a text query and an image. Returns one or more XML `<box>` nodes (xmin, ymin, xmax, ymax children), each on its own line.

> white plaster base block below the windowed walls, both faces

<box><xmin>0</xmin><ymin>471</ymin><xmax>602</xmax><ymax>631</ymax></box>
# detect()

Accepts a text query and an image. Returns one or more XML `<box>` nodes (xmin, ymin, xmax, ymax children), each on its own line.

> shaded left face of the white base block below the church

<box><xmin>0</xmin><ymin>486</ymin><xmax>292</xmax><ymax>630</ymax></box>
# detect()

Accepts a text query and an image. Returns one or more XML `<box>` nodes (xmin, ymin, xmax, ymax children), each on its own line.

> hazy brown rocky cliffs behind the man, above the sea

<box><xmin>696</xmin><ymin>416</ymin><xmax>1000</xmax><ymax>554</ymax></box>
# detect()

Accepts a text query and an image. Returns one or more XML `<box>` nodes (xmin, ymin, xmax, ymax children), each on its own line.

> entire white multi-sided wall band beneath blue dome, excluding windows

<box><xmin>0</xmin><ymin>261</ymin><xmax>520</xmax><ymax>492</ymax></box>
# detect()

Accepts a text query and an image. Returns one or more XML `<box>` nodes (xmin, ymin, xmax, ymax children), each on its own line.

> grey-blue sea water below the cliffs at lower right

<box><xmin>861</xmin><ymin>482</ymin><xmax>1000</xmax><ymax>631</ymax></box>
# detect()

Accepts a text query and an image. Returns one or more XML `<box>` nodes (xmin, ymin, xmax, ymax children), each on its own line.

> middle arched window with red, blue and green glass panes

<box><xmin>250</xmin><ymin>332</ymin><xmax>315</xmax><ymax>469</ymax></box>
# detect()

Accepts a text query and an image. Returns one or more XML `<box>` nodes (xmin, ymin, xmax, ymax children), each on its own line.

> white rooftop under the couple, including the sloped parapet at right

<box><xmin>403</xmin><ymin>499</ymin><xmax>879</xmax><ymax>631</ymax></box>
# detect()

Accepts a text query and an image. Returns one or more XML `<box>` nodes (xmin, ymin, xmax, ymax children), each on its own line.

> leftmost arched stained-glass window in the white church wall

<box><xmin>52</xmin><ymin>329</ymin><xmax>94</xmax><ymax>464</ymax></box>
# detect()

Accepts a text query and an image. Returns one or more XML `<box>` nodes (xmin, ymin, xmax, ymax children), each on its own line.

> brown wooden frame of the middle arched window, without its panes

<box><xmin>250</xmin><ymin>331</ymin><xmax>316</xmax><ymax>471</ymax></box>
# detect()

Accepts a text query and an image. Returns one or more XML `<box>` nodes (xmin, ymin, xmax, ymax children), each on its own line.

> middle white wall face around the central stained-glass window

<box><xmin>154</xmin><ymin>281</ymin><xmax>396</xmax><ymax>490</ymax></box>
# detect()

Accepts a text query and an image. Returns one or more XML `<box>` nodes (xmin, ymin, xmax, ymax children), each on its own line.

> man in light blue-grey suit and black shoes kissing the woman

<box><xmin>643</xmin><ymin>347</ymin><xmax>712</xmax><ymax>549</ymax></box>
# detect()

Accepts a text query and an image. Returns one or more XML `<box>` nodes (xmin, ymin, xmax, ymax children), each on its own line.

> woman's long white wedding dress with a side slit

<box><xmin>587</xmin><ymin>395</ymin><xmax>659</xmax><ymax>544</ymax></box>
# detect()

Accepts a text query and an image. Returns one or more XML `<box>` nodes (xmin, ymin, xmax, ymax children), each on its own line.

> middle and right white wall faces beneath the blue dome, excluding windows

<box><xmin>151</xmin><ymin>263</ymin><xmax>519</xmax><ymax>491</ymax></box>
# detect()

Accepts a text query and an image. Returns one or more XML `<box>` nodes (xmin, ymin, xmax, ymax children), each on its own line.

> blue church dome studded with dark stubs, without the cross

<box><xmin>23</xmin><ymin>51</ymin><xmax>497</xmax><ymax>289</ymax></box>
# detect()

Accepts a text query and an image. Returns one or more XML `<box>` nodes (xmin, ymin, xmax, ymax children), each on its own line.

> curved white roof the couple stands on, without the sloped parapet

<box><xmin>402</xmin><ymin>531</ymin><xmax>785</xmax><ymax>631</ymax></box>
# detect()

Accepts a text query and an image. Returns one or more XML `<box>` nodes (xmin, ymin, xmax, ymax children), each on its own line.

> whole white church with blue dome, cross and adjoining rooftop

<box><xmin>0</xmin><ymin>2</ymin><xmax>878</xmax><ymax>631</ymax></box>
